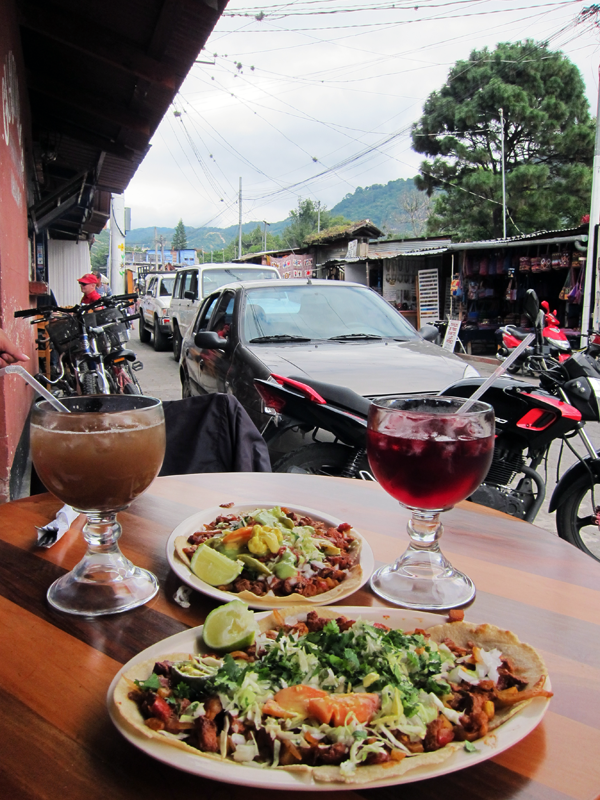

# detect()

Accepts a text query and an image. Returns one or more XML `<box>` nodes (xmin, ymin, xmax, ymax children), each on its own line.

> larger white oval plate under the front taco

<box><xmin>107</xmin><ymin>606</ymin><xmax>551</xmax><ymax>792</ymax></box>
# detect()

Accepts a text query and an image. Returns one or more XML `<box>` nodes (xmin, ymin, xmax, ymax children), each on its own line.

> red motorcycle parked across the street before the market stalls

<box><xmin>496</xmin><ymin>289</ymin><xmax>571</xmax><ymax>377</ymax></box>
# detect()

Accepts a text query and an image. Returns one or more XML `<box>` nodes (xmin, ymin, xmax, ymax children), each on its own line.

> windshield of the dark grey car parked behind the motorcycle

<box><xmin>244</xmin><ymin>281</ymin><xmax>419</xmax><ymax>343</ymax></box>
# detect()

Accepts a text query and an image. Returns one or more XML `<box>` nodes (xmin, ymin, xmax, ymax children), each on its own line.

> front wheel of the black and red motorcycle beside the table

<box><xmin>556</xmin><ymin>475</ymin><xmax>600</xmax><ymax>561</ymax></box>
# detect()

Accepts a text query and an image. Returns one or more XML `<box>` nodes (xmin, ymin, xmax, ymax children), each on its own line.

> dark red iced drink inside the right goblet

<box><xmin>368</xmin><ymin>419</ymin><xmax>494</xmax><ymax>509</ymax></box>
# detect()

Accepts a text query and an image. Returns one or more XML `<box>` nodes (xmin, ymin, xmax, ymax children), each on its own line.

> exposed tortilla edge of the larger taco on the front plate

<box><xmin>113</xmin><ymin>598</ymin><xmax>548</xmax><ymax>785</ymax></box>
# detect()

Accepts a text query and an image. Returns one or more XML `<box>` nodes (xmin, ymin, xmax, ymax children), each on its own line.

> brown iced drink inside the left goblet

<box><xmin>31</xmin><ymin>409</ymin><xmax>165</xmax><ymax>511</ymax></box>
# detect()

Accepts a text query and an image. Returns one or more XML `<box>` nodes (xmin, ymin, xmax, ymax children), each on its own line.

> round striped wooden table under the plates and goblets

<box><xmin>0</xmin><ymin>473</ymin><xmax>600</xmax><ymax>800</ymax></box>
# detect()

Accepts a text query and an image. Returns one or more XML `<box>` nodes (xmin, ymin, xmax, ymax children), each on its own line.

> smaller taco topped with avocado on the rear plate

<box><xmin>174</xmin><ymin>506</ymin><xmax>363</xmax><ymax>608</ymax></box>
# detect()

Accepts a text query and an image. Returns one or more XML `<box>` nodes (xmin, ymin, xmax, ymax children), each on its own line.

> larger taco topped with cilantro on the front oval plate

<box><xmin>113</xmin><ymin>607</ymin><xmax>552</xmax><ymax>784</ymax></box>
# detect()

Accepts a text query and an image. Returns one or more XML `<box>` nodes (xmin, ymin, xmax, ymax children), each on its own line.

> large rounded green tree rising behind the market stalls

<box><xmin>412</xmin><ymin>40</ymin><xmax>594</xmax><ymax>240</ymax></box>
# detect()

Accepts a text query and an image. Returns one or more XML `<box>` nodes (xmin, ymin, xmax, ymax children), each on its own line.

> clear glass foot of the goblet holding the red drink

<box><xmin>370</xmin><ymin>545</ymin><xmax>475</xmax><ymax>611</ymax></box>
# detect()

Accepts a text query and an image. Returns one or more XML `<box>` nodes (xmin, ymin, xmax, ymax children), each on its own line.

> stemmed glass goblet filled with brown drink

<box><xmin>31</xmin><ymin>395</ymin><xmax>165</xmax><ymax>616</ymax></box>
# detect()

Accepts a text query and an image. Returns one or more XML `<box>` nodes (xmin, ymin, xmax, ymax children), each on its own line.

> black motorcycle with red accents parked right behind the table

<box><xmin>254</xmin><ymin>344</ymin><xmax>600</xmax><ymax>560</ymax></box>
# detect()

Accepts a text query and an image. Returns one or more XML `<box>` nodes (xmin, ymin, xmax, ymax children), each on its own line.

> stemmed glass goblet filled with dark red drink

<box><xmin>367</xmin><ymin>395</ymin><xmax>495</xmax><ymax>611</ymax></box>
